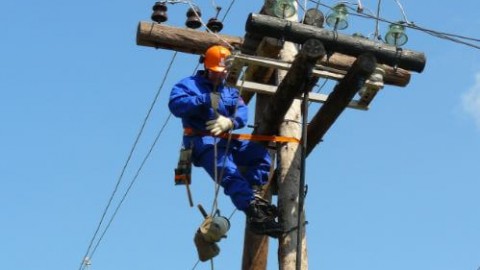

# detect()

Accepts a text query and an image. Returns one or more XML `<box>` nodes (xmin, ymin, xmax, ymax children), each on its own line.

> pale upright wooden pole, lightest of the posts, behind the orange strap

<box><xmin>258</xmin><ymin>0</ymin><xmax>310</xmax><ymax>270</ymax></box>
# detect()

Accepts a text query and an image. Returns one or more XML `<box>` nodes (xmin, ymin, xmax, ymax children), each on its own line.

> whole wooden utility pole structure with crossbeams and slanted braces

<box><xmin>137</xmin><ymin>0</ymin><xmax>426</xmax><ymax>270</ymax></box>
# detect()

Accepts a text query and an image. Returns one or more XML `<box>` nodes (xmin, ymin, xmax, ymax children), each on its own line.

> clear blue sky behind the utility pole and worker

<box><xmin>0</xmin><ymin>0</ymin><xmax>480</xmax><ymax>270</ymax></box>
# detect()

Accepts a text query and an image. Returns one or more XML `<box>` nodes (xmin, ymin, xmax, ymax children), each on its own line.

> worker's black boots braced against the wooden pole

<box><xmin>245</xmin><ymin>197</ymin><xmax>283</xmax><ymax>238</ymax></box>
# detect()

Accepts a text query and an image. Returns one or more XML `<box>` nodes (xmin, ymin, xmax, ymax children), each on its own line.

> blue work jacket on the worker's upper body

<box><xmin>168</xmin><ymin>71</ymin><xmax>248</xmax><ymax>156</ymax></box>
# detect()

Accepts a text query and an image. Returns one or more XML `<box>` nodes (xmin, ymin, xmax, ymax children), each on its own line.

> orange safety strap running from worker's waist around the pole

<box><xmin>183</xmin><ymin>128</ymin><xmax>300</xmax><ymax>143</ymax></box>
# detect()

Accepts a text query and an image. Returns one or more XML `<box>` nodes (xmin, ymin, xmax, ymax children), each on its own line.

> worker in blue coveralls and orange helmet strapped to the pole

<box><xmin>168</xmin><ymin>45</ymin><xmax>283</xmax><ymax>237</ymax></box>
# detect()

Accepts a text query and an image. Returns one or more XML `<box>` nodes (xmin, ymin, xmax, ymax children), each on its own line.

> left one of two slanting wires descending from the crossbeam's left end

<box><xmin>79</xmin><ymin>52</ymin><xmax>177</xmax><ymax>270</ymax></box>
